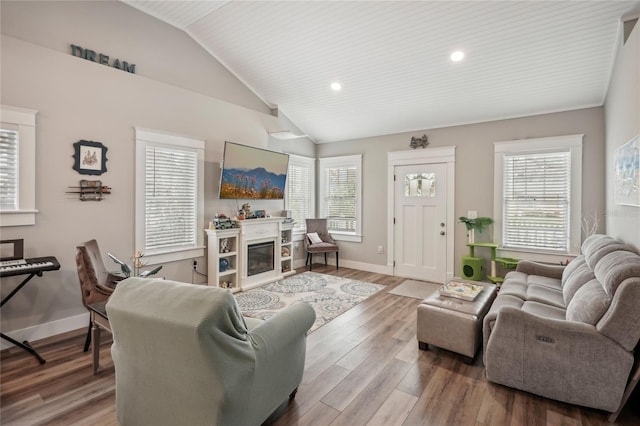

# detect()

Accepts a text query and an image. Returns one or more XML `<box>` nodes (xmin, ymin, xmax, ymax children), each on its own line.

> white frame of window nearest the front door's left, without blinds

<box><xmin>318</xmin><ymin>154</ymin><xmax>362</xmax><ymax>242</ymax></box>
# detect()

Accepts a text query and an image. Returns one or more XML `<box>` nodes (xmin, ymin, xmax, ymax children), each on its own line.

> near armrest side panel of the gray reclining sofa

<box><xmin>485</xmin><ymin>306</ymin><xmax>633</xmax><ymax>412</ymax></box>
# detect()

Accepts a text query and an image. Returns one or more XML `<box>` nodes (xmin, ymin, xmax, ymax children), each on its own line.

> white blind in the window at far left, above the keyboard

<box><xmin>0</xmin><ymin>126</ymin><xmax>19</xmax><ymax>210</ymax></box>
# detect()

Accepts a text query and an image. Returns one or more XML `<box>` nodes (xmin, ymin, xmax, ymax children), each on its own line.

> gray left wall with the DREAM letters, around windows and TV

<box><xmin>0</xmin><ymin>1</ymin><xmax>315</xmax><ymax>338</ymax></box>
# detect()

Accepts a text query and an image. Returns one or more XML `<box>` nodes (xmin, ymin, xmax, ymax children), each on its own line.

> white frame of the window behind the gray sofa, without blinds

<box><xmin>494</xmin><ymin>134</ymin><xmax>584</xmax><ymax>262</ymax></box>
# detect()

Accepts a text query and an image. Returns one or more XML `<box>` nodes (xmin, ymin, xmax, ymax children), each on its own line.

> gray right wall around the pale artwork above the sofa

<box><xmin>605</xmin><ymin>23</ymin><xmax>640</xmax><ymax>252</ymax></box>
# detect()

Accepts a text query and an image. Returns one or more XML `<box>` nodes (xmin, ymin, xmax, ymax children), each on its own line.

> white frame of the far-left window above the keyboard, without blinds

<box><xmin>0</xmin><ymin>105</ymin><xmax>38</xmax><ymax>227</ymax></box>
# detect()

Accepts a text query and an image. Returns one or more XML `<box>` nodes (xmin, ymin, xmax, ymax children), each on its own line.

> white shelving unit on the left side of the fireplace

<box><xmin>205</xmin><ymin>228</ymin><xmax>240</xmax><ymax>293</ymax></box>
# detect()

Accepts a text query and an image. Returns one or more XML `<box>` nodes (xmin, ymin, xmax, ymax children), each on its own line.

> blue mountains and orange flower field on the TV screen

<box><xmin>220</xmin><ymin>167</ymin><xmax>287</xmax><ymax>199</ymax></box>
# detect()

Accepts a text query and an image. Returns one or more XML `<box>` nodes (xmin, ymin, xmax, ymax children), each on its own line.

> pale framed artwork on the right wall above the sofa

<box><xmin>614</xmin><ymin>135</ymin><xmax>640</xmax><ymax>207</ymax></box>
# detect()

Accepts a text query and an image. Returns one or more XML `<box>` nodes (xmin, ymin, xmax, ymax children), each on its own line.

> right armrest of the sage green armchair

<box><xmin>249</xmin><ymin>303</ymin><xmax>316</xmax><ymax>353</ymax></box>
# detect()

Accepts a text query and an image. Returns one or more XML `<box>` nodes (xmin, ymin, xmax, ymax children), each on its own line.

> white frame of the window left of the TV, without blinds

<box><xmin>135</xmin><ymin>128</ymin><xmax>205</xmax><ymax>265</ymax></box>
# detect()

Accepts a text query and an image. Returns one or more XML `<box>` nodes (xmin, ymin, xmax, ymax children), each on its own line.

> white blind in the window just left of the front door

<box><xmin>327</xmin><ymin>166</ymin><xmax>358</xmax><ymax>233</ymax></box>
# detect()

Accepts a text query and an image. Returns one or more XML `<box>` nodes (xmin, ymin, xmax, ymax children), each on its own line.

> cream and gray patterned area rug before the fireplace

<box><xmin>235</xmin><ymin>272</ymin><xmax>385</xmax><ymax>332</ymax></box>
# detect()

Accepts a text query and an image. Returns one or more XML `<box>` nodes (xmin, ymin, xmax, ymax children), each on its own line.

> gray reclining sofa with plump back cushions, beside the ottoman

<box><xmin>483</xmin><ymin>235</ymin><xmax>640</xmax><ymax>412</ymax></box>
